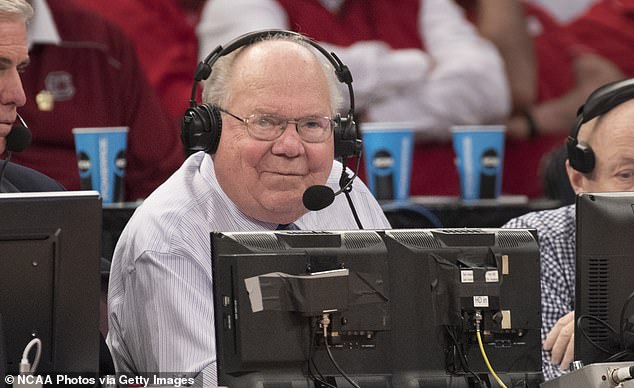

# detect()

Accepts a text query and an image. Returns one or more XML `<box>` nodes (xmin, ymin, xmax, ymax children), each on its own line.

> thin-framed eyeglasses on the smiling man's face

<box><xmin>218</xmin><ymin>108</ymin><xmax>333</xmax><ymax>143</ymax></box>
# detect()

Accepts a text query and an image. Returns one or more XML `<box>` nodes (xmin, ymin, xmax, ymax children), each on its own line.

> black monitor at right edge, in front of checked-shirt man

<box><xmin>574</xmin><ymin>192</ymin><xmax>634</xmax><ymax>365</ymax></box>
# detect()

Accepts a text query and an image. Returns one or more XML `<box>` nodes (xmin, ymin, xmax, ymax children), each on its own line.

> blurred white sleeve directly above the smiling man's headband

<box><xmin>196</xmin><ymin>0</ymin><xmax>289</xmax><ymax>60</ymax></box>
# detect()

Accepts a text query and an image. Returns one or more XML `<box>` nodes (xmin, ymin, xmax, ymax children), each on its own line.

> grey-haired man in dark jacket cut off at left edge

<box><xmin>0</xmin><ymin>0</ymin><xmax>63</xmax><ymax>193</ymax></box>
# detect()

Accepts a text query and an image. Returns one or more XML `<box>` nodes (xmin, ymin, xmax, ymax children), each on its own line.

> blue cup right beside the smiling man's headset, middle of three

<box><xmin>361</xmin><ymin>122</ymin><xmax>414</xmax><ymax>200</ymax></box>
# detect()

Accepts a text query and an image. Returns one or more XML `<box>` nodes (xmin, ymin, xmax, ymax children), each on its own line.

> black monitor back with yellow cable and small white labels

<box><xmin>385</xmin><ymin>228</ymin><xmax>543</xmax><ymax>387</ymax></box>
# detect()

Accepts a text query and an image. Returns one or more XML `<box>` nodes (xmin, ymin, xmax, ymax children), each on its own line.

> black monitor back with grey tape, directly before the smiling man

<box><xmin>212</xmin><ymin>231</ymin><xmax>392</xmax><ymax>387</ymax></box>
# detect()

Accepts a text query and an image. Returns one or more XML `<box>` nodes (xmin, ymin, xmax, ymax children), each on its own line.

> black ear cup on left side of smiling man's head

<box><xmin>181</xmin><ymin>104</ymin><xmax>222</xmax><ymax>154</ymax></box>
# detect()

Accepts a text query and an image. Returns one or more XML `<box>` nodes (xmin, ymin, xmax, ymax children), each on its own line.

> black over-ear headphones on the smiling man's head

<box><xmin>181</xmin><ymin>30</ymin><xmax>362</xmax><ymax>158</ymax></box>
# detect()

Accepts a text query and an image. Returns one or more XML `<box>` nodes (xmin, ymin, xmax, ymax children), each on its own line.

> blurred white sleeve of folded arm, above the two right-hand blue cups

<box><xmin>367</xmin><ymin>0</ymin><xmax>511</xmax><ymax>139</ymax></box>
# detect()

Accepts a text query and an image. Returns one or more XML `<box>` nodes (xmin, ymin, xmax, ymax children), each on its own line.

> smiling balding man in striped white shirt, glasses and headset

<box><xmin>107</xmin><ymin>31</ymin><xmax>390</xmax><ymax>386</ymax></box>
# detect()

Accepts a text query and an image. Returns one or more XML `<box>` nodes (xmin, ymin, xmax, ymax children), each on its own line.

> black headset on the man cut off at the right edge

<box><xmin>566</xmin><ymin>78</ymin><xmax>634</xmax><ymax>174</ymax></box>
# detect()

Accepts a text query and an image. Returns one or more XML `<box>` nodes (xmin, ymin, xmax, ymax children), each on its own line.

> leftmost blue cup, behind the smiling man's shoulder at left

<box><xmin>73</xmin><ymin>127</ymin><xmax>128</xmax><ymax>203</ymax></box>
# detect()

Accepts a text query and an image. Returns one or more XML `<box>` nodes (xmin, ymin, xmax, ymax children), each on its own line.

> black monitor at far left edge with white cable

<box><xmin>0</xmin><ymin>191</ymin><xmax>101</xmax><ymax>374</ymax></box>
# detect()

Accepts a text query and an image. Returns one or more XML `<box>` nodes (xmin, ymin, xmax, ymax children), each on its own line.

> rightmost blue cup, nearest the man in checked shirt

<box><xmin>451</xmin><ymin>125</ymin><xmax>506</xmax><ymax>200</ymax></box>
